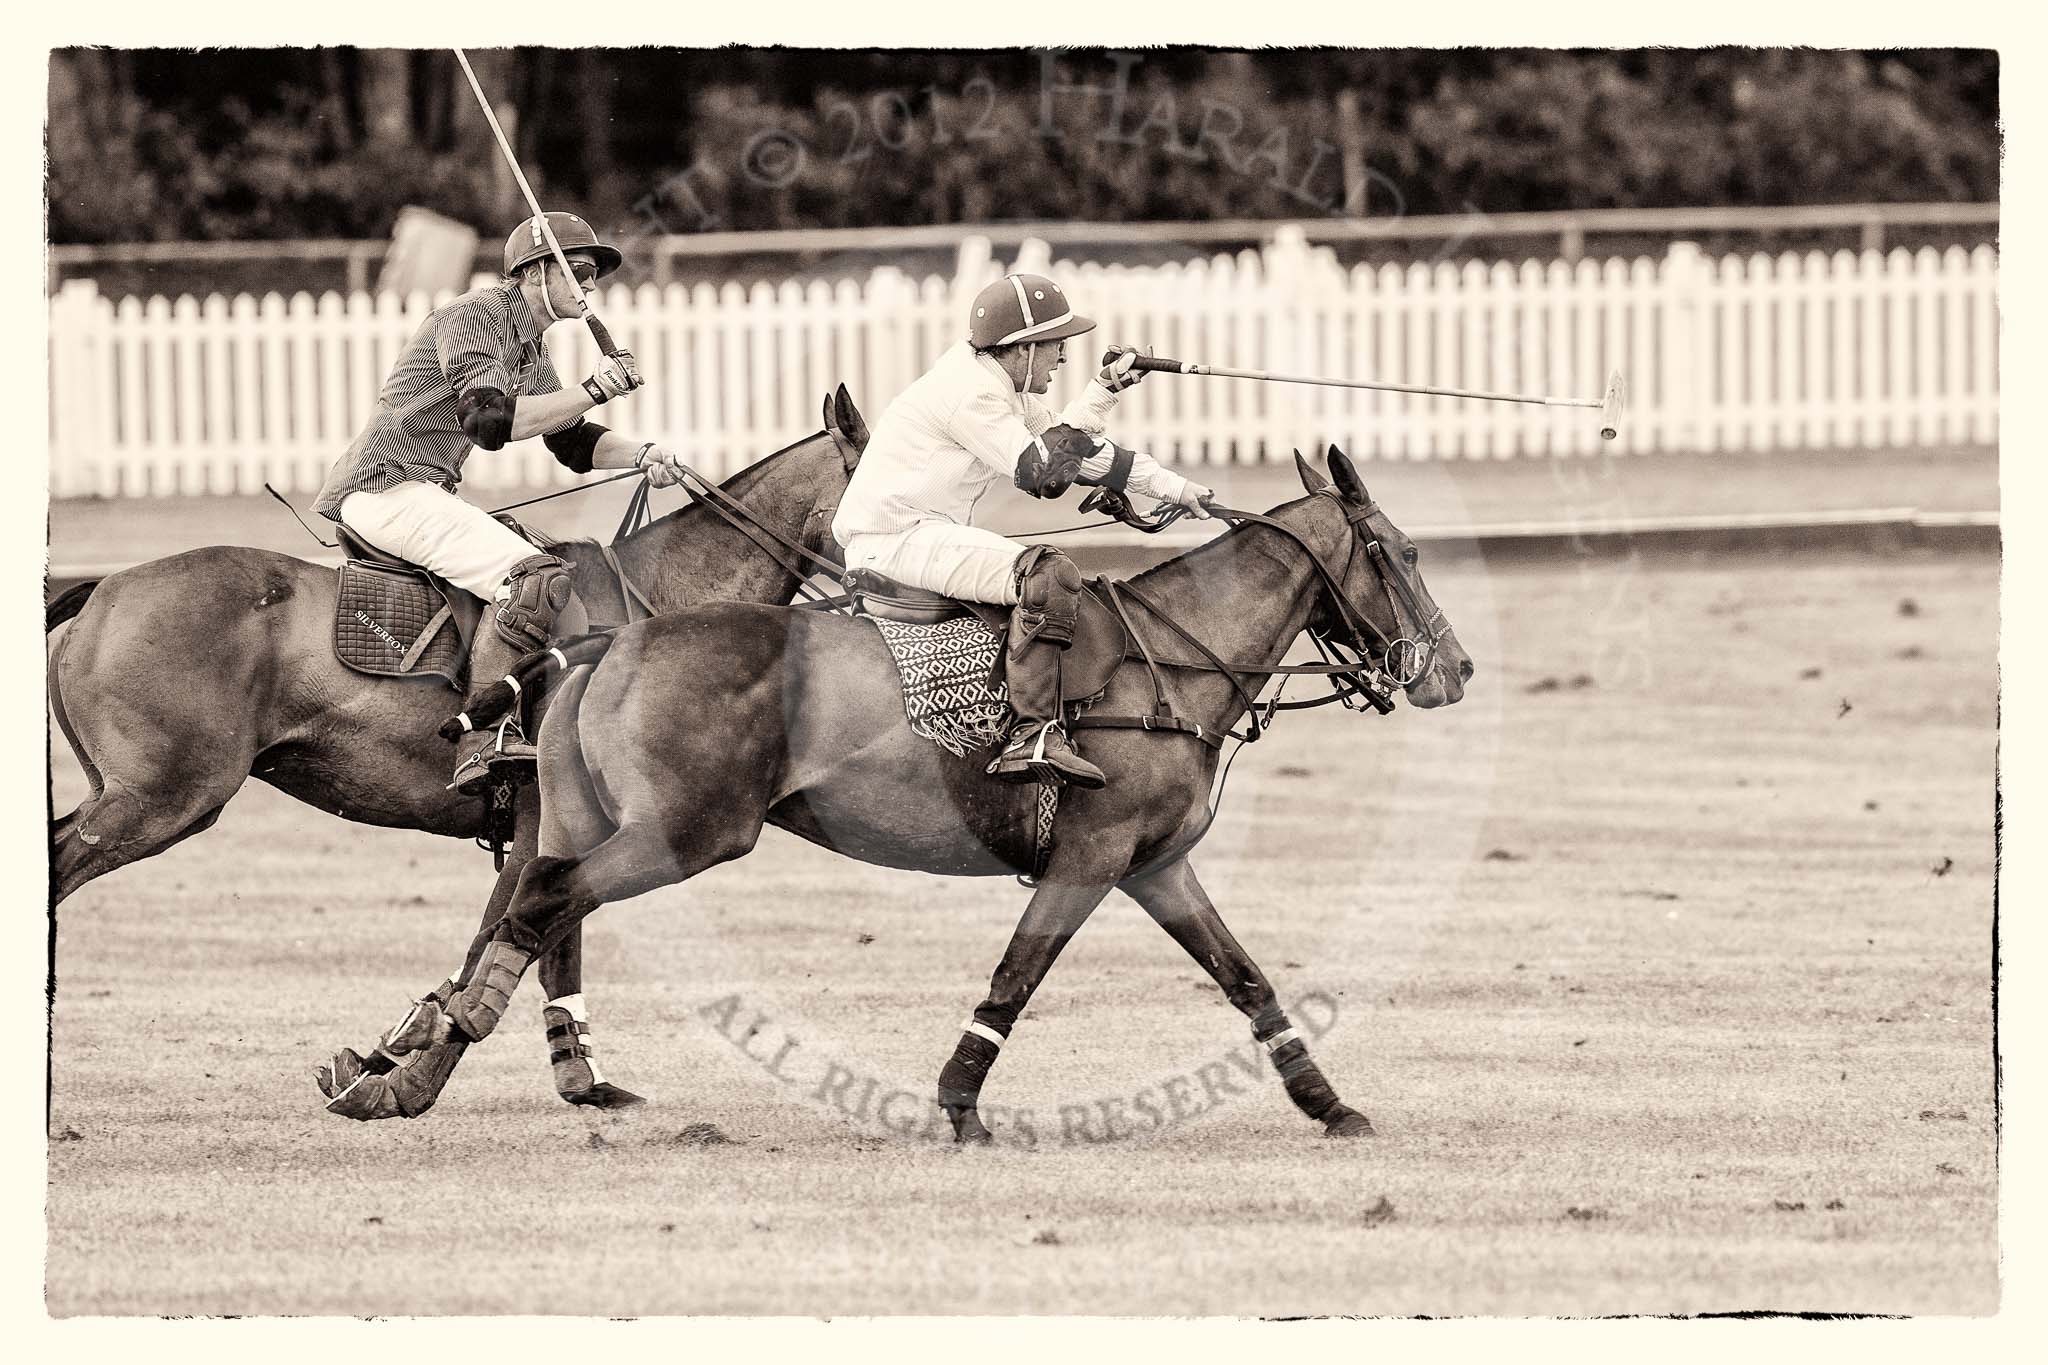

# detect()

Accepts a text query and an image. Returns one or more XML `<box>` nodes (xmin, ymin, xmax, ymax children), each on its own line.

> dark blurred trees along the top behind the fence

<box><xmin>49</xmin><ymin>47</ymin><xmax>1999</xmax><ymax>241</ymax></box>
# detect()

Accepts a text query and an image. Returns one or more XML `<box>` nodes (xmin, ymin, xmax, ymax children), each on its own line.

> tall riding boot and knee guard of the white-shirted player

<box><xmin>989</xmin><ymin>544</ymin><xmax>1108</xmax><ymax>790</ymax></box>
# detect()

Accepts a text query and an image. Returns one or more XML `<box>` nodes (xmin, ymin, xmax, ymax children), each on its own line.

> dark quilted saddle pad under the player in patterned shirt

<box><xmin>334</xmin><ymin>516</ymin><xmax>539</xmax><ymax>692</ymax></box>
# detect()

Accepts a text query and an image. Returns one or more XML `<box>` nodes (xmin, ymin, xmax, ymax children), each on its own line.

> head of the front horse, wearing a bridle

<box><xmin>1294</xmin><ymin>446</ymin><xmax>1473</xmax><ymax>708</ymax></box>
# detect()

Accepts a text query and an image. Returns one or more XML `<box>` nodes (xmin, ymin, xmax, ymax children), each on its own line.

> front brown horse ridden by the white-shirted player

<box><xmin>348</xmin><ymin>448</ymin><xmax>1473</xmax><ymax>1140</ymax></box>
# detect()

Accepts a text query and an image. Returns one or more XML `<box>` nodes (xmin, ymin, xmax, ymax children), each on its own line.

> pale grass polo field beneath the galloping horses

<box><xmin>47</xmin><ymin>555</ymin><xmax>1999</xmax><ymax>1316</ymax></box>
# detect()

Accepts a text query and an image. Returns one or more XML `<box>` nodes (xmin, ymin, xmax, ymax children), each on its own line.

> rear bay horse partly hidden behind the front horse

<box><xmin>45</xmin><ymin>385</ymin><xmax>868</xmax><ymax>1105</ymax></box>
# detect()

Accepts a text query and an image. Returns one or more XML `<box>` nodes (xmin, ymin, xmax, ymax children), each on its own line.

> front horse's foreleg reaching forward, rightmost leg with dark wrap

<box><xmin>1122</xmin><ymin>857</ymin><xmax>1372</xmax><ymax>1138</ymax></box>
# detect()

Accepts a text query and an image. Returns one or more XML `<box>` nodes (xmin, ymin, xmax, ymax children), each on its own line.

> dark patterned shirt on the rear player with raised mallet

<box><xmin>313</xmin><ymin>284</ymin><xmax>582</xmax><ymax>522</ymax></box>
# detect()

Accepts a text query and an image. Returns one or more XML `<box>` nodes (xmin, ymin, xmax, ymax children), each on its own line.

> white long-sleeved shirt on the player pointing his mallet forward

<box><xmin>831</xmin><ymin>342</ymin><xmax>1188</xmax><ymax>544</ymax></box>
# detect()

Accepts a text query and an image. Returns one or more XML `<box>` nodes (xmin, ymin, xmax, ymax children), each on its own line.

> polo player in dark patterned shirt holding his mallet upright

<box><xmin>313</xmin><ymin>213</ymin><xmax>680</xmax><ymax>794</ymax></box>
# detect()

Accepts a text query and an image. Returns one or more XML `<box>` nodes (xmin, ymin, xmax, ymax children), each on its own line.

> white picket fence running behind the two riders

<box><xmin>49</xmin><ymin>229</ymin><xmax>1999</xmax><ymax>497</ymax></box>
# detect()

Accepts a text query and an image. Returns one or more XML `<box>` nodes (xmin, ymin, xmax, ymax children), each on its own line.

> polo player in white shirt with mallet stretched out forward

<box><xmin>831</xmin><ymin>274</ymin><xmax>1214</xmax><ymax>788</ymax></box>
